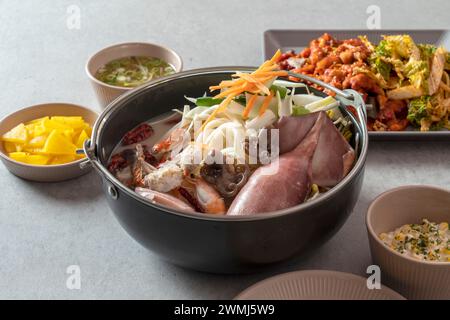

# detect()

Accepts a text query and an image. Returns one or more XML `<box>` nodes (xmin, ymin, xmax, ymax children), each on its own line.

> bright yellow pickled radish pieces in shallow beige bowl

<box><xmin>1</xmin><ymin>116</ymin><xmax>92</xmax><ymax>165</ymax></box>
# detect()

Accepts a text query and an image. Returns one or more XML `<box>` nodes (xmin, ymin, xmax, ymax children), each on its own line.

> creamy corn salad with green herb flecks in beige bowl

<box><xmin>380</xmin><ymin>219</ymin><xmax>450</xmax><ymax>262</ymax></box>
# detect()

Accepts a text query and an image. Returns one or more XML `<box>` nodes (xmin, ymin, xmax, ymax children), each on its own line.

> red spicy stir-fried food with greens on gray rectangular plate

<box><xmin>278</xmin><ymin>34</ymin><xmax>450</xmax><ymax>131</ymax></box>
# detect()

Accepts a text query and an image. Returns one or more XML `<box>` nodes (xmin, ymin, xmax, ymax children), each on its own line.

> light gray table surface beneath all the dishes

<box><xmin>0</xmin><ymin>0</ymin><xmax>450</xmax><ymax>299</ymax></box>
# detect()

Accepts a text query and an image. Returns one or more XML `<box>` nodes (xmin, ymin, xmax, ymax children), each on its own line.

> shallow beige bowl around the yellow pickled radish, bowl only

<box><xmin>0</xmin><ymin>103</ymin><xmax>98</xmax><ymax>182</ymax></box>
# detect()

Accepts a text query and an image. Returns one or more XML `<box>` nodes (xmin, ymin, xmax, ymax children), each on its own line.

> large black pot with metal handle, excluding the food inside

<box><xmin>85</xmin><ymin>67</ymin><xmax>368</xmax><ymax>273</ymax></box>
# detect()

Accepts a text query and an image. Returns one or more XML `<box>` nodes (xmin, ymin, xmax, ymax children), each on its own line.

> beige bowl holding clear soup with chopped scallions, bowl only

<box><xmin>86</xmin><ymin>42</ymin><xmax>183</xmax><ymax>108</ymax></box>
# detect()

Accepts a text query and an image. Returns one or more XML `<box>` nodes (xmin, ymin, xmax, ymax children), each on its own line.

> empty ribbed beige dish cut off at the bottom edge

<box><xmin>235</xmin><ymin>270</ymin><xmax>405</xmax><ymax>300</ymax></box>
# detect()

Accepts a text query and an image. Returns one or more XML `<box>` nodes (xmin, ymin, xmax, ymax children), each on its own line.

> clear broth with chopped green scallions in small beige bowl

<box><xmin>95</xmin><ymin>56</ymin><xmax>175</xmax><ymax>87</ymax></box>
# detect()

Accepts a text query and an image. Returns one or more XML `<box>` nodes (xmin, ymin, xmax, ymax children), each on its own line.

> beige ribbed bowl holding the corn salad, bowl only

<box><xmin>366</xmin><ymin>186</ymin><xmax>450</xmax><ymax>299</ymax></box>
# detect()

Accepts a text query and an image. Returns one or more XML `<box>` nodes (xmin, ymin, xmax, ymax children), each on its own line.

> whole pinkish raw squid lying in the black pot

<box><xmin>227</xmin><ymin>111</ymin><xmax>355</xmax><ymax>215</ymax></box>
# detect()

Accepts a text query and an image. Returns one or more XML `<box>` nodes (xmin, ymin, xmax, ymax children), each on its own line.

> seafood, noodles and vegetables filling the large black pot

<box><xmin>108</xmin><ymin>51</ymin><xmax>356</xmax><ymax>215</ymax></box>
